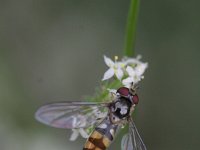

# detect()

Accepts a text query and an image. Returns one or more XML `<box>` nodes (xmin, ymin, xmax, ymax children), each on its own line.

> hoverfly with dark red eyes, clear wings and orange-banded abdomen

<box><xmin>35</xmin><ymin>87</ymin><xmax>146</xmax><ymax>150</ymax></box>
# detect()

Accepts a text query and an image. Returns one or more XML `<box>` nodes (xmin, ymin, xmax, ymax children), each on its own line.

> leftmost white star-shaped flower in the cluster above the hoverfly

<box><xmin>102</xmin><ymin>56</ymin><xmax>125</xmax><ymax>81</ymax></box>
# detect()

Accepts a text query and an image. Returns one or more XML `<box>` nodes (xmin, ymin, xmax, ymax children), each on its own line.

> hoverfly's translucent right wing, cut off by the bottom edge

<box><xmin>121</xmin><ymin>120</ymin><xmax>147</xmax><ymax>150</ymax></box>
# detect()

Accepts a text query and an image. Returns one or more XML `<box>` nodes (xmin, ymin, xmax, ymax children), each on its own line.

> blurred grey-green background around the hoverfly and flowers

<box><xmin>0</xmin><ymin>0</ymin><xmax>200</xmax><ymax>150</ymax></box>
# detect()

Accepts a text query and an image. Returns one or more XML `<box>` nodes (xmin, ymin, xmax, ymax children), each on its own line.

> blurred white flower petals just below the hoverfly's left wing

<box><xmin>69</xmin><ymin>128</ymin><xmax>89</xmax><ymax>141</ymax></box>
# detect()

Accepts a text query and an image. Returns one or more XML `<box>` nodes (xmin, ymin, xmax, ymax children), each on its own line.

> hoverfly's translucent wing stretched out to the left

<box><xmin>35</xmin><ymin>102</ymin><xmax>109</xmax><ymax>129</ymax></box>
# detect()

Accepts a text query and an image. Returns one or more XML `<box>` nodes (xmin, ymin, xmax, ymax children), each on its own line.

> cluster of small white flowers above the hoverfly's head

<box><xmin>102</xmin><ymin>56</ymin><xmax>148</xmax><ymax>87</ymax></box>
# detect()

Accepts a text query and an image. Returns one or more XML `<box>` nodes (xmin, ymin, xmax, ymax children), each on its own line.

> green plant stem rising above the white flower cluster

<box><xmin>124</xmin><ymin>0</ymin><xmax>139</xmax><ymax>57</ymax></box>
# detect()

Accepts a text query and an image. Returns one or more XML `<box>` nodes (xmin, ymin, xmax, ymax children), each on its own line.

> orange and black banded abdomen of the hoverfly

<box><xmin>83</xmin><ymin>118</ymin><xmax>118</xmax><ymax>150</ymax></box>
